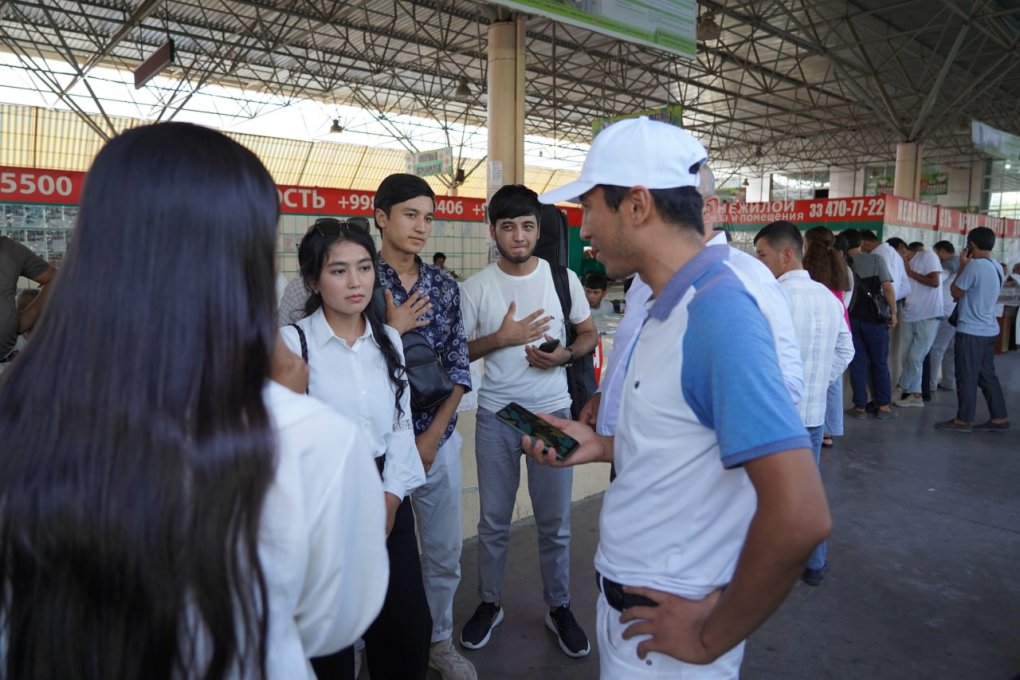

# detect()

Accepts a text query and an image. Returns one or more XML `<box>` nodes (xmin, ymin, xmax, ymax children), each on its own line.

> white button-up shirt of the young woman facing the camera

<box><xmin>281</xmin><ymin>308</ymin><xmax>425</xmax><ymax>501</ymax></box>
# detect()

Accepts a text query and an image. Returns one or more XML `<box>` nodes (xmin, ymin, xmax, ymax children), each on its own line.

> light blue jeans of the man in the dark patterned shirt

<box><xmin>411</xmin><ymin>430</ymin><xmax>463</xmax><ymax>642</ymax></box>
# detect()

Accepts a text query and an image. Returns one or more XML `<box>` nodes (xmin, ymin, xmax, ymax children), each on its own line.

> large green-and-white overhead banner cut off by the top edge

<box><xmin>494</xmin><ymin>0</ymin><xmax>698</xmax><ymax>59</ymax></box>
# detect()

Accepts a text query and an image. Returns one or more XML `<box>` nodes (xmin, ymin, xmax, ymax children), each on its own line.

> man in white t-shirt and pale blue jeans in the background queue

<box><xmin>887</xmin><ymin>239</ymin><xmax>944</xmax><ymax>407</ymax></box>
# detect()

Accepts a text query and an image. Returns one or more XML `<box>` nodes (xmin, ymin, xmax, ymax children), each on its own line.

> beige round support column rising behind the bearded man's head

<box><xmin>486</xmin><ymin>15</ymin><xmax>524</xmax><ymax>197</ymax></box>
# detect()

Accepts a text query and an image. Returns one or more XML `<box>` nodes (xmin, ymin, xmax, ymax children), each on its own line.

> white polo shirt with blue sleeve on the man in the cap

<box><xmin>595</xmin><ymin>248</ymin><xmax>811</xmax><ymax>598</ymax></box>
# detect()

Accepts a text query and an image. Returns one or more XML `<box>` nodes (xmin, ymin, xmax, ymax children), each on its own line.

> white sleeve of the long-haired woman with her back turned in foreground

<box><xmin>294</xmin><ymin>413</ymin><xmax>390</xmax><ymax>657</ymax></box>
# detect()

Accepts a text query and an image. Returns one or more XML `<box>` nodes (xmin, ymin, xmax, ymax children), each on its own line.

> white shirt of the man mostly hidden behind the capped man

<box><xmin>708</xmin><ymin>231</ymin><xmax>803</xmax><ymax>404</ymax></box>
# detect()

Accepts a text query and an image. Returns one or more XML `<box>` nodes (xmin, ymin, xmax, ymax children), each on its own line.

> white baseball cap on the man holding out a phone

<box><xmin>539</xmin><ymin>115</ymin><xmax>708</xmax><ymax>203</ymax></box>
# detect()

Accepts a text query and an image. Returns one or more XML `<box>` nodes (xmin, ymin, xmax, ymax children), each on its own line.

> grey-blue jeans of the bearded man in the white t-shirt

<box><xmin>474</xmin><ymin>407</ymin><xmax>573</xmax><ymax>607</ymax></box>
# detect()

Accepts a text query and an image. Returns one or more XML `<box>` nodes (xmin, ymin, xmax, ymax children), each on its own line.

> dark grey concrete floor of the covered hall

<box><xmin>429</xmin><ymin>352</ymin><xmax>1020</xmax><ymax>680</ymax></box>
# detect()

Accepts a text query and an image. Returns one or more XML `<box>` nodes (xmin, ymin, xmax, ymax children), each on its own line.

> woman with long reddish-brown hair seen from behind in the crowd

<box><xmin>804</xmin><ymin>226</ymin><xmax>854</xmax><ymax>449</ymax></box>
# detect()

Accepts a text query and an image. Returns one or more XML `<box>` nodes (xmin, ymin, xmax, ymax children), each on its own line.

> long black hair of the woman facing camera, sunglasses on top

<box><xmin>298</xmin><ymin>217</ymin><xmax>407</xmax><ymax>419</ymax></box>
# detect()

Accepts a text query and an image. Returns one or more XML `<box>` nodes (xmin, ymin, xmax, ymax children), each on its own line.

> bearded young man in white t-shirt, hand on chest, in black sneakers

<box><xmin>461</xmin><ymin>185</ymin><xmax>598</xmax><ymax>657</ymax></box>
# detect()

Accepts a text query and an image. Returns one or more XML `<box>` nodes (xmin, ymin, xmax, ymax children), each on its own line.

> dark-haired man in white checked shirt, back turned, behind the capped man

<box><xmin>755</xmin><ymin>220</ymin><xmax>854</xmax><ymax>585</ymax></box>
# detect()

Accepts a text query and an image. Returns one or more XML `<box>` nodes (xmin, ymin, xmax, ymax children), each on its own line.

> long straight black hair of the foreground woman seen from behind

<box><xmin>0</xmin><ymin>123</ymin><xmax>278</xmax><ymax>680</ymax></box>
